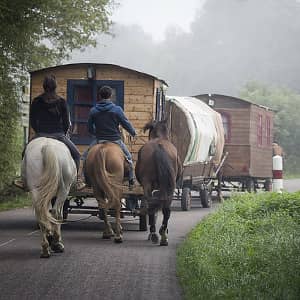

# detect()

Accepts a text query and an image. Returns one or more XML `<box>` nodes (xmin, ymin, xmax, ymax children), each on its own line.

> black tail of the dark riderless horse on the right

<box><xmin>153</xmin><ymin>144</ymin><xmax>176</xmax><ymax>199</ymax></box>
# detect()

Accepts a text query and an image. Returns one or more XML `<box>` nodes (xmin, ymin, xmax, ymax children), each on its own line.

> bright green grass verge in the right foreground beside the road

<box><xmin>177</xmin><ymin>193</ymin><xmax>300</xmax><ymax>300</ymax></box>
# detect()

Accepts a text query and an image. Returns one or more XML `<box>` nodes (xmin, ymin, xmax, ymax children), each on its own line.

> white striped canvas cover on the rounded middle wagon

<box><xmin>166</xmin><ymin>96</ymin><xmax>224</xmax><ymax>165</ymax></box>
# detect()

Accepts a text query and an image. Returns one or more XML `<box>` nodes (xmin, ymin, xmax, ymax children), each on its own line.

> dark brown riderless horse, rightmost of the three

<box><xmin>135</xmin><ymin>121</ymin><xmax>182</xmax><ymax>246</ymax></box>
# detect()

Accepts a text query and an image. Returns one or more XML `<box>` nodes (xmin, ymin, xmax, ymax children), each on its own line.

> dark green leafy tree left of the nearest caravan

<box><xmin>0</xmin><ymin>0</ymin><xmax>114</xmax><ymax>190</ymax></box>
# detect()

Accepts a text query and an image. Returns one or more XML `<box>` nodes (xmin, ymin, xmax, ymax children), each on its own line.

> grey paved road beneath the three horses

<box><xmin>0</xmin><ymin>202</ymin><xmax>213</xmax><ymax>300</ymax></box>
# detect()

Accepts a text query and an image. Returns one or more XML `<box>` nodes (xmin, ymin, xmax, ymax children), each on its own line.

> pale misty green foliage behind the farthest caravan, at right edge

<box><xmin>240</xmin><ymin>82</ymin><xmax>300</xmax><ymax>174</ymax></box>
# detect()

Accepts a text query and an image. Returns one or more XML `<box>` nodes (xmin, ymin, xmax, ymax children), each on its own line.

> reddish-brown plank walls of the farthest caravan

<box><xmin>195</xmin><ymin>95</ymin><xmax>274</xmax><ymax>178</ymax></box>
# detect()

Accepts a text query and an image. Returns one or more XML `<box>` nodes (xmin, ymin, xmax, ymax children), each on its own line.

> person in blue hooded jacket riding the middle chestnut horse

<box><xmin>83</xmin><ymin>86</ymin><xmax>137</xmax><ymax>188</ymax></box>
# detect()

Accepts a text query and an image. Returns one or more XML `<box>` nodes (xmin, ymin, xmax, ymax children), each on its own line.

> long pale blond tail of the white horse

<box><xmin>33</xmin><ymin>145</ymin><xmax>62</xmax><ymax>227</ymax></box>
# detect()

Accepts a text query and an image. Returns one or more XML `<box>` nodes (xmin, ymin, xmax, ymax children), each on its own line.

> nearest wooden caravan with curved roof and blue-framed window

<box><xmin>30</xmin><ymin>63</ymin><xmax>167</xmax><ymax>160</ymax></box>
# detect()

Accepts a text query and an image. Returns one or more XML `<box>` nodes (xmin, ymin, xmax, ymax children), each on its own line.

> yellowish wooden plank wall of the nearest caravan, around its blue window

<box><xmin>31</xmin><ymin>64</ymin><xmax>160</xmax><ymax>160</ymax></box>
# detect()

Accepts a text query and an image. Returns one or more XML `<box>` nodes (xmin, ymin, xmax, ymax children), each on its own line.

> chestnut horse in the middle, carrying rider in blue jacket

<box><xmin>85</xmin><ymin>142</ymin><xmax>128</xmax><ymax>243</ymax></box>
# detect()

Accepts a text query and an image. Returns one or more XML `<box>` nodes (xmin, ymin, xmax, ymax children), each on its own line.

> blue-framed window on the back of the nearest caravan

<box><xmin>67</xmin><ymin>80</ymin><xmax>124</xmax><ymax>145</ymax></box>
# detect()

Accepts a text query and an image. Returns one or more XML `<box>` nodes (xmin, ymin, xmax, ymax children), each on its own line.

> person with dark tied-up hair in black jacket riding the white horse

<box><xmin>14</xmin><ymin>75</ymin><xmax>85</xmax><ymax>190</ymax></box>
